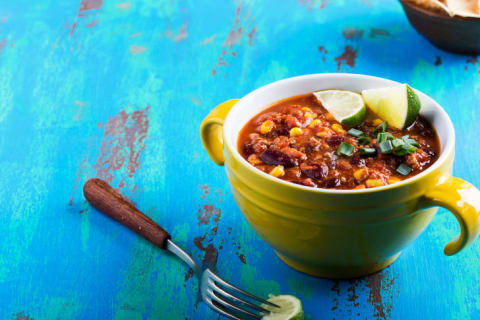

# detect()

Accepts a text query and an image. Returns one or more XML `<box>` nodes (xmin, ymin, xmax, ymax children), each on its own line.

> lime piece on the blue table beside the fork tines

<box><xmin>262</xmin><ymin>295</ymin><xmax>304</xmax><ymax>320</ymax></box>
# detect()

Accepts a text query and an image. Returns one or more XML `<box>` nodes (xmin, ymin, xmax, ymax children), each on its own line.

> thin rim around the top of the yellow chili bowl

<box><xmin>223</xmin><ymin>73</ymin><xmax>455</xmax><ymax>195</ymax></box>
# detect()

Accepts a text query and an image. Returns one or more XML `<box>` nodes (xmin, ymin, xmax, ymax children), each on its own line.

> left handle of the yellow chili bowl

<box><xmin>200</xmin><ymin>99</ymin><xmax>238</xmax><ymax>166</ymax></box>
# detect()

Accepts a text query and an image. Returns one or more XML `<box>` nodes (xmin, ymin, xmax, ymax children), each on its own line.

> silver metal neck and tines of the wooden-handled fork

<box><xmin>167</xmin><ymin>240</ymin><xmax>279</xmax><ymax>320</ymax></box>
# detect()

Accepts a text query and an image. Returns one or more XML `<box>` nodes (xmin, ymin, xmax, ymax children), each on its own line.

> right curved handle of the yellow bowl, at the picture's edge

<box><xmin>424</xmin><ymin>176</ymin><xmax>480</xmax><ymax>256</ymax></box>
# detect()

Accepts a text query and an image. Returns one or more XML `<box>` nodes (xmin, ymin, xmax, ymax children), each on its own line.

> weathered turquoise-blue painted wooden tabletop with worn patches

<box><xmin>0</xmin><ymin>0</ymin><xmax>480</xmax><ymax>320</ymax></box>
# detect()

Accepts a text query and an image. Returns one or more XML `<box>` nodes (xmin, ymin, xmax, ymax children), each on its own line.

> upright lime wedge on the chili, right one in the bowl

<box><xmin>362</xmin><ymin>84</ymin><xmax>420</xmax><ymax>129</ymax></box>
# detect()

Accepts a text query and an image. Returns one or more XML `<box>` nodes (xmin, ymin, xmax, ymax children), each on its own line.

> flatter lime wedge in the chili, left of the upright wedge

<box><xmin>313</xmin><ymin>90</ymin><xmax>367</xmax><ymax>126</ymax></box>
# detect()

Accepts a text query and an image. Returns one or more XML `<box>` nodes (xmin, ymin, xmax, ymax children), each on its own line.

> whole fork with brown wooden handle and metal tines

<box><xmin>83</xmin><ymin>178</ymin><xmax>280</xmax><ymax>320</ymax></box>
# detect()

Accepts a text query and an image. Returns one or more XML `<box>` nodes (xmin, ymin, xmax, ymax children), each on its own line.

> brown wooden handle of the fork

<box><xmin>83</xmin><ymin>178</ymin><xmax>170</xmax><ymax>249</ymax></box>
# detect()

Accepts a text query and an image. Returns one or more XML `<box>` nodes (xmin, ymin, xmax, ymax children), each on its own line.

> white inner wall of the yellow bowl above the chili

<box><xmin>223</xmin><ymin>73</ymin><xmax>455</xmax><ymax>191</ymax></box>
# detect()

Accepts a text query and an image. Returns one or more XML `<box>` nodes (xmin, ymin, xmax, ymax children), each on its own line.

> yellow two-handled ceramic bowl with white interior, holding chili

<box><xmin>201</xmin><ymin>74</ymin><xmax>480</xmax><ymax>278</ymax></box>
